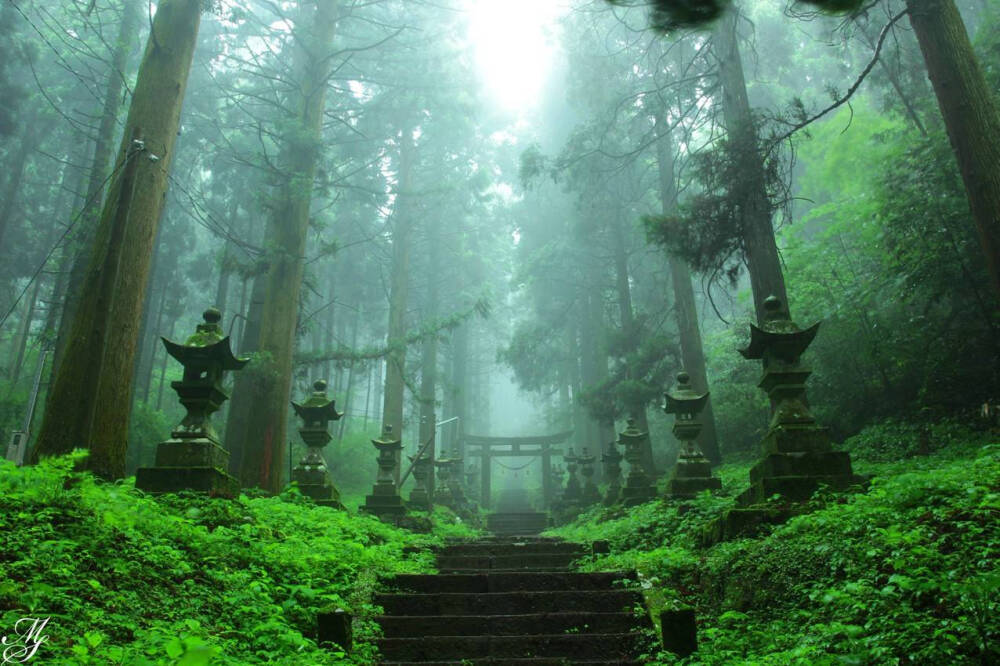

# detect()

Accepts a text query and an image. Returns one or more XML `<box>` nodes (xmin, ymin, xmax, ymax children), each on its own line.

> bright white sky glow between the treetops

<box><xmin>467</xmin><ymin>0</ymin><xmax>566</xmax><ymax>112</ymax></box>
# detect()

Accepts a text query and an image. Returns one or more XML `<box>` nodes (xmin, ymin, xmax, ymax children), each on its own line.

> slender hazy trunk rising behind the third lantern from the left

<box><xmin>382</xmin><ymin>127</ymin><xmax>413</xmax><ymax>486</ymax></box>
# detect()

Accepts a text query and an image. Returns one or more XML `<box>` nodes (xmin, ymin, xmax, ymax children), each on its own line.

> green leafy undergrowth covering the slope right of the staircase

<box><xmin>548</xmin><ymin>424</ymin><xmax>1000</xmax><ymax>665</ymax></box>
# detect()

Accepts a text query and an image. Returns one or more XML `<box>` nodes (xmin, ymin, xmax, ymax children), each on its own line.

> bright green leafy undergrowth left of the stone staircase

<box><xmin>0</xmin><ymin>452</ymin><xmax>474</xmax><ymax>666</ymax></box>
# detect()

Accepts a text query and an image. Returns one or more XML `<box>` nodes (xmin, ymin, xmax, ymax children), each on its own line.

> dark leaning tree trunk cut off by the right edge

<box><xmin>906</xmin><ymin>0</ymin><xmax>1000</xmax><ymax>303</ymax></box>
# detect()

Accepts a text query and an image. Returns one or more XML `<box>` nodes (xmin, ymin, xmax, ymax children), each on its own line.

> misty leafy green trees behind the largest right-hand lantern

<box><xmin>783</xmin><ymin>100</ymin><xmax>1000</xmax><ymax>435</ymax></box>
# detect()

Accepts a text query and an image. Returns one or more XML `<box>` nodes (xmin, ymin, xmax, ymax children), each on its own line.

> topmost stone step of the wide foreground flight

<box><xmin>389</xmin><ymin>571</ymin><xmax>635</xmax><ymax>593</ymax></box>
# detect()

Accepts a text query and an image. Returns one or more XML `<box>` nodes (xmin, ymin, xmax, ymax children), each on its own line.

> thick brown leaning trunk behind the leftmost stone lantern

<box><xmin>36</xmin><ymin>0</ymin><xmax>201</xmax><ymax>479</ymax></box>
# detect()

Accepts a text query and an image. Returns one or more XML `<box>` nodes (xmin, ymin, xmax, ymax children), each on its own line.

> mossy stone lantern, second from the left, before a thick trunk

<box><xmin>292</xmin><ymin>379</ymin><xmax>344</xmax><ymax>509</ymax></box>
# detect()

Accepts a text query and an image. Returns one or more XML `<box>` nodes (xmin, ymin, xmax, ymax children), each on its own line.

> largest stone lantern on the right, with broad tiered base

<box><xmin>737</xmin><ymin>296</ymin><xmax>865</xmax><ymax>506</ymax></box>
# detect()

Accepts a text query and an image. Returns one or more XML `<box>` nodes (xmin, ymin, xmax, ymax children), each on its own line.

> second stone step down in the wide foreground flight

<box><xmin>375</xmin><ymin>590</ymin><xmax>642</xmax><ymax>615</ymax></box>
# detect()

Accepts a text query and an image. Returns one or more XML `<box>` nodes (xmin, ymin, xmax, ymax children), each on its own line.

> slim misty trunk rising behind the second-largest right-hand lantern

<box><xmin>656</xmin><ymin>114</ymin><xmax>722</xmax><ymax>465</ymax></box>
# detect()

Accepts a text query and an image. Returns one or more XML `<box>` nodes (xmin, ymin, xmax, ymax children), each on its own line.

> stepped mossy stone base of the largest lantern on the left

<box><xmin>135</xmin><ymin>437</ymin><xmax>240</xmax><ymax>497</ymax></box>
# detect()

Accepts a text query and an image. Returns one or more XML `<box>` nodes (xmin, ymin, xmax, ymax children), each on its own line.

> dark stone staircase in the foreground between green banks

<box><xmin>375</xmin><ymin>537</ymin><xmax>651</xmax><ymax>666</ymax></box>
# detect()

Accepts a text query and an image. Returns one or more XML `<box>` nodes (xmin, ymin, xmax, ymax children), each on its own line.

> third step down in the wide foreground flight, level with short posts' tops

<box><xmin>377</xmin><ymin>612</ymin><xmax>649</xmax><ymax>638</ymax></box>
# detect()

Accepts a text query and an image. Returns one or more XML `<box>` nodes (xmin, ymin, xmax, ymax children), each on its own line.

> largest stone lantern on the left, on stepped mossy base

<box><xmin>135</xmin><ymin>308</ymin><xmax>248</xmax><ymax>497</ymax></box>
